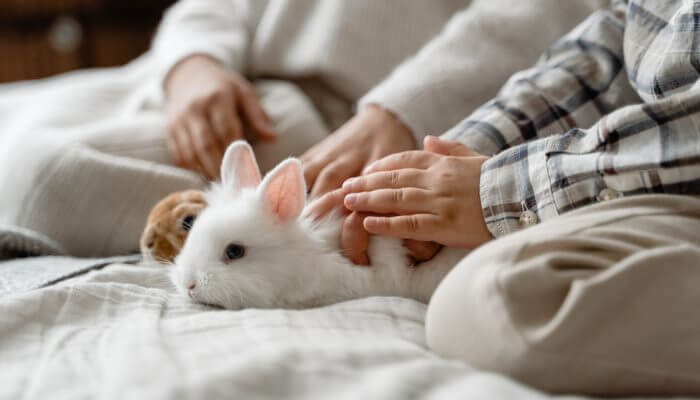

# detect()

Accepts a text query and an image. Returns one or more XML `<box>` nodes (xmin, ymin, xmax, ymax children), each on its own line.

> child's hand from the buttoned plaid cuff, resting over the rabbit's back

<box><xmin>343</xmin><ymin>138</ymin><xmax>492</xmax><ymax>248</ymax></box>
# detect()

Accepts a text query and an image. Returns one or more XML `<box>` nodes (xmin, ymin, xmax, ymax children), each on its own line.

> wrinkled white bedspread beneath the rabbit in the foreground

<box><xmin>0</xmin><ymin>265</ymin><xmax>688</xmax><ymax>400</ymax></box>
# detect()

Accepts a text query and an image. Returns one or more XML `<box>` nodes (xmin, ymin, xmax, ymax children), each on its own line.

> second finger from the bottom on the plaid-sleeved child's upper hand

<box><xmin>343</xmin><ymin>188</ymin><xmax>434</xmax><ymax>214</ymax></box>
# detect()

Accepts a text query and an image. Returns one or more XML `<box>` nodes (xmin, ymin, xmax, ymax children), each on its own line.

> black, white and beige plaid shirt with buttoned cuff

<box><xmin>443</xmin><ymin>0</ymin><xmax>700</xmax><ymax>236</ymax></box>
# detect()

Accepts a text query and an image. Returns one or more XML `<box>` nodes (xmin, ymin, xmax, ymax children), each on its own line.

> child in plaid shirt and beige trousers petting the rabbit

<box><xmin>314</xmin><ymin>0</ymin><xmax>700</xmax><ymax>395</ymax></box>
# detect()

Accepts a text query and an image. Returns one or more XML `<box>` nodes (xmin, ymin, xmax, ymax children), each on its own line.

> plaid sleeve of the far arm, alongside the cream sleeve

<box><xmin>444</xmin><ymin>10</ymin><xmax>638</xmax><ymax>154</ymax></box>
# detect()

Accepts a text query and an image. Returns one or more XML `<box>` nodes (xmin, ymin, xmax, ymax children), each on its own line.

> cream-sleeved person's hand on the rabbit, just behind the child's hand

<box><xmin>301</xmin><ymin>105</ymin><xmax>416</xmax><ymax>197</ymax></box>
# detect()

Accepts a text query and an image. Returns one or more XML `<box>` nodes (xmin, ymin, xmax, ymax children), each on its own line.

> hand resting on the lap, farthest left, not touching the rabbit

<box><xmin>165</xmin><ymin>55</ymin><xmax>277</xmax><ymax>179</ymax></box>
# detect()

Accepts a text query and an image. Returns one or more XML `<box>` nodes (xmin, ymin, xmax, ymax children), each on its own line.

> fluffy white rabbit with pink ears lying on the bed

<box><xmin>172</xmin><ymin>141</ymin><xmax>467</xmax><ymax>309</ymax></box>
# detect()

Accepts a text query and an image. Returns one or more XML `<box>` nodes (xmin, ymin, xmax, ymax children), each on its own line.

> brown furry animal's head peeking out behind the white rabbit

<box><xmin>140</xmin><ymin>190</ymin><xmax>207</xmax><ymax>264</ymax></box>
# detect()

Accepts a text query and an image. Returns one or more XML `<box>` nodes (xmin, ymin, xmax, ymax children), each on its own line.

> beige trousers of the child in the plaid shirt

<box><xmin>426</xmin><ymin>195</ymin><xmax>700</xmax><ymax>395</ymax></box>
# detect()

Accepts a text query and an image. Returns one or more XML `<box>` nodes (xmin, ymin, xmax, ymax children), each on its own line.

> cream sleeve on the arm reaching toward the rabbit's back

<box><xmin>360</xmin><ymin>0</ymin><xmax>599</xmax><ymax>143</ymax></box>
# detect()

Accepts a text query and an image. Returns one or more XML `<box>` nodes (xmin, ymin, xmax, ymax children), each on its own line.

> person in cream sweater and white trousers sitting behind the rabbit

<box><xmin>0</xmin><ymin>0</ymin><xmax>599</xmax><ymax>256</ymax></box>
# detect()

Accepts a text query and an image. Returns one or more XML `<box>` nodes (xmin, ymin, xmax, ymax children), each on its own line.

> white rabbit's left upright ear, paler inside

<box><xmin>221</xmin><ymin>140</ymin><xmax>260</xmax><ymax>191</ymax></box>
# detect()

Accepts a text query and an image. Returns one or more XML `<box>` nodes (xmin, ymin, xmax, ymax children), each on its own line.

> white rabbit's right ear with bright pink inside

<box><xmin>258</xmin><ymin>158</ymin><xmax>306</xmax><ymax>223</ymax></box>
